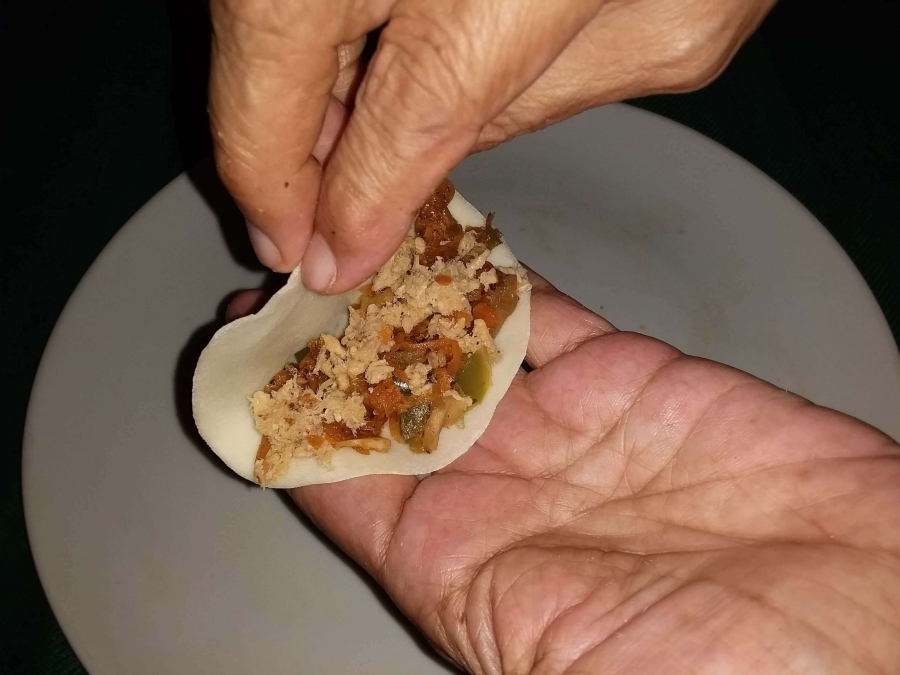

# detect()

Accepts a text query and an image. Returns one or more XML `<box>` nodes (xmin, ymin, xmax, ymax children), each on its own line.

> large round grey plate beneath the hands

<box><xmin>24</xmin><ymin>106</ymin><xmax>900</xmax><ymax>675</ymax></box>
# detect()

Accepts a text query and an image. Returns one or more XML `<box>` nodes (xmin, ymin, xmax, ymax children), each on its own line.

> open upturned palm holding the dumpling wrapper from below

<box><xmin>231</xmin><ymin>278</ymin><xmax>900</xmax><ymax>675</ymax></box>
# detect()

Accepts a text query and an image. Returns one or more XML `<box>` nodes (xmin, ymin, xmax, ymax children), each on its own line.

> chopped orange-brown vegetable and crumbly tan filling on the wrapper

<box><xmin>250</xmin><ymin>180</ymin><xmax>528</xmax><ymax>485</ymax></box>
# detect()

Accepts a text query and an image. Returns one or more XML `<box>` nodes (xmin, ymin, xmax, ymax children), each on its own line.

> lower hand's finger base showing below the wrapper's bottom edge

<box><xmin>291</xmin><ymin>475</ymin><xmax>419</xmax><ymax>579</ymax></box>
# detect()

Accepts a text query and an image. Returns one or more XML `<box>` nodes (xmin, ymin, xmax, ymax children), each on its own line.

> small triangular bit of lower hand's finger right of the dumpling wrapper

<box><xmin>525</xmin><ymin>270</ymin><xmax>616</xmax><ymax>368</ymax></box>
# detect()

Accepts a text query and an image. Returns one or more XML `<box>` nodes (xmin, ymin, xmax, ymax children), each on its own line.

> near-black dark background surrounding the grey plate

<box><xmin>0</xmin><ymin>0</ymin><xmax>900</xmax><ymax>674</ymax></box>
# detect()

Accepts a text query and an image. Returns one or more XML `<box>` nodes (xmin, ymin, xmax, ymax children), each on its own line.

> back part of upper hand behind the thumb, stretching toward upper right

<box><xmin>476</xmin><ymin>0</ymin><xmax>774</xmax><ymax>150</ymax></box>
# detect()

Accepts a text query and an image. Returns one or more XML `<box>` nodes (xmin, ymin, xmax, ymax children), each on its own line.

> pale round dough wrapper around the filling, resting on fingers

<box><xmin>192</xmin><ymin>194</ymin><xmax>531</xmax><ymax>488</ymax></box>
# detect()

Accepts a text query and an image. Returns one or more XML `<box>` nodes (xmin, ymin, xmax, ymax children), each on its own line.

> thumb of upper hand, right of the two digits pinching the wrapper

<box><xmin>303</xmin><ymin>0</ymin><xmax>603</xmax><ymax>293</ymax></box>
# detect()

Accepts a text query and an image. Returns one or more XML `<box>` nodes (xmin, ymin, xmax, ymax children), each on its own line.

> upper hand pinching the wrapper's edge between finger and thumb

<box><xmin>210</xmin><ymin>0</ymin><xmax>775</xmax><ymax>293</ymax></box>
